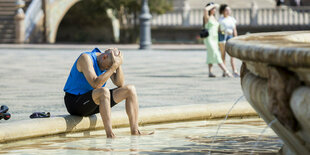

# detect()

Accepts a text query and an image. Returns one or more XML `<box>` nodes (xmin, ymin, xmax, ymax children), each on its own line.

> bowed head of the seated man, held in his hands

<box><xmin>99</xmin><ymin>48</ymin><xmax>119</xmax><ymax>70</ymax></box>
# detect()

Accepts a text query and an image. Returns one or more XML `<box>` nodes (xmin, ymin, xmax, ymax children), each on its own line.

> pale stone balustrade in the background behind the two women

<box><xmin>129</xmin><ymin>7</ymin><xmax>310</xmax><ymax>27</ymax></box>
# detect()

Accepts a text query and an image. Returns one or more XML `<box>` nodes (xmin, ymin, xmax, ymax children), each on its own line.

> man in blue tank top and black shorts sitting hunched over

<box><xmin>64</xmin><ymin>48</ymin><xmax>149</xmax><ymax>138</ymax></box>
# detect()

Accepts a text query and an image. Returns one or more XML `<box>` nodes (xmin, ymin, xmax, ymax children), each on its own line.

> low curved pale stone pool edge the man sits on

<box><xmin>0</xmin><ymin>102</ymin><xmax>257</xmax><ymax>144</ymax></box>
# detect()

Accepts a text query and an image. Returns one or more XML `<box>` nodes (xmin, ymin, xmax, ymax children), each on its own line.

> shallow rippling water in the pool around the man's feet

<box><xmin>0</xmin><ymin>118</ymin><xmax>282</xmax><ymax>154</ymax></box>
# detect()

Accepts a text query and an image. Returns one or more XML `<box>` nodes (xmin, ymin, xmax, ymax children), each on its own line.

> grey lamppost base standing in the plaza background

<box><xmin>139</xmin><ymin>0</ymin><xmax>152</xmax><ymax>49</ymax></box>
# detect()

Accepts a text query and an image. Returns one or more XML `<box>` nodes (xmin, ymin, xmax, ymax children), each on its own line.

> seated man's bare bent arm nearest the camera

<box><xmin>77</xmin><ymin>54</ymin><xmax>119</xmax><ymax>89</ymax></box>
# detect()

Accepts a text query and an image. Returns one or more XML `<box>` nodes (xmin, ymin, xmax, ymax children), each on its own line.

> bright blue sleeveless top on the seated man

<box><xmin>64</xmin><ymin>48</ymin><xmax>106</xmax><ymax>95</ymax></box>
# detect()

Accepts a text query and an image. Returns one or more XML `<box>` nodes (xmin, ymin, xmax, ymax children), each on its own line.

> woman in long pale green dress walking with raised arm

<box><xmin>203</xmin><ymin>2</ymin><xmax>232</xmax><ymax>77</ymax></box>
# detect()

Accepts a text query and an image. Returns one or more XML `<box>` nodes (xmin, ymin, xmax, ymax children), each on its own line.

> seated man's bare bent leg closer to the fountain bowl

<box><xmin>113</xmin><ymin>85</ymin><xmax>141</xmax><ymax>135</ymax></box>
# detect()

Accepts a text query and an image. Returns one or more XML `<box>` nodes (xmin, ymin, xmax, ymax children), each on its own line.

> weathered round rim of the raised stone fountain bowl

<box><xmin>226</xmin><ymin>31</ymin><xmax>310</xmax><ymax>67</ymax></box>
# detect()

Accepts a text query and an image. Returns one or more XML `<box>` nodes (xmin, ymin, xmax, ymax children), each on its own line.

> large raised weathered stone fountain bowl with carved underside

<box><xmin>226</xmin><ymin>31</ymin><xmax>310</xmax><ymax>154</ymax></box>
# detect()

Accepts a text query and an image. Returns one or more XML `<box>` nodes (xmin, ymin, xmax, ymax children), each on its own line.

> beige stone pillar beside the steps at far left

<box><xmin>14</xmin><ymin>0</ymin><xmax>25</xmax><ymax>44</ymax></box>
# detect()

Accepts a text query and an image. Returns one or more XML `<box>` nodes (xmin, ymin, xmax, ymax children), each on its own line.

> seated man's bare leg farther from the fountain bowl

<box><xmin>92</xmin><ymin>87</ymin><xmax>115</xmax><ymax>138</ymax></box>
